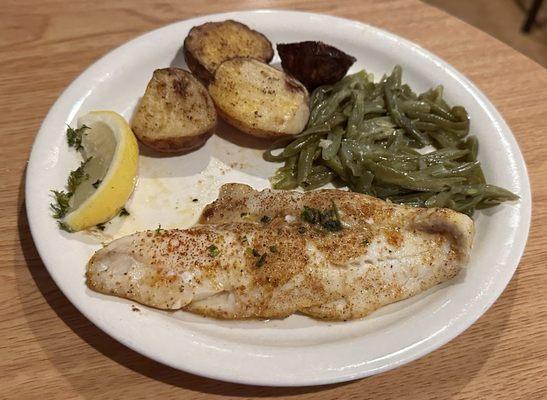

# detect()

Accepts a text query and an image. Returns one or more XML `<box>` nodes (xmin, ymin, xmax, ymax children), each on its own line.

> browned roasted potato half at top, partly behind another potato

<box><xmin>183</xmin><ymin>20</ymin><xmax>273</xmax><ymax>82</ymax></box>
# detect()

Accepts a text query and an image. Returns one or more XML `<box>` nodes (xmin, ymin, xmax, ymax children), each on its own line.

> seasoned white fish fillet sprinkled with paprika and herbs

<box><xmin>86</xmin><ymin>184</ymin><xmax>474</xmax><ymax>320</ymax></box>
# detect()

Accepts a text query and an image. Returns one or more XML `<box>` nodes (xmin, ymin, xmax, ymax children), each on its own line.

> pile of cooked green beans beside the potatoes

<box><xmin>264</xmin><ymin>66</ymin><xmax>518</xmax><ymax>215</ymax></box>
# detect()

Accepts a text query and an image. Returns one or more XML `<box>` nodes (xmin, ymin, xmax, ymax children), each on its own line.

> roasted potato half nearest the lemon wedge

<box><xmin>131</xmin><ymin>68</ymin><xmax>217</xmax><ymax>153</ymax></box>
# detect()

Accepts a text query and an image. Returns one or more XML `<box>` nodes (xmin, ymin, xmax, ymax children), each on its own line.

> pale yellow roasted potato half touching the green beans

<box><xmin>209</xmin><ymin>57</ymin><xmax>310</xmax><ymax>138</ymax></box>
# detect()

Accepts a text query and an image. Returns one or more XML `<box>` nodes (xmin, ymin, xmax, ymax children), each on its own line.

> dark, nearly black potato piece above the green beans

<box><xmin>277</xmin><ymin>41</ymin><xmax>355</xmax><ymax>91</ymax></box>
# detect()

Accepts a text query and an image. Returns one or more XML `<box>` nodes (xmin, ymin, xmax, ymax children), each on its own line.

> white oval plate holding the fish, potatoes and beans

<box><xmin>26</xmin><ymin>10</ymin><xmax>531</xmax><ymax>386</ymax></box>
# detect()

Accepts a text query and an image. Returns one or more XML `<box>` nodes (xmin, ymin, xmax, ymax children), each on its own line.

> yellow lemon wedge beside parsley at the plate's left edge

<box><xmin>62</xmin><ymin>111</ymin><xmax>139</xmax><ymax>231</ymax></box>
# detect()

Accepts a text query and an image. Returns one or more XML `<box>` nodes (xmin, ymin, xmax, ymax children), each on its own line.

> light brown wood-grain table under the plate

<box><xmin>0</xmin><ymin>0</ymin><xmax>547</xmax><ymax>399</ymax></box>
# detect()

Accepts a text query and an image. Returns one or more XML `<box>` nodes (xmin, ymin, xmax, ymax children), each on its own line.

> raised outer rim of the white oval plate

<box><xmin>25</xmin><ymin>9</ymin><xmax>532</xmax><ymax>386</ymax></box>
